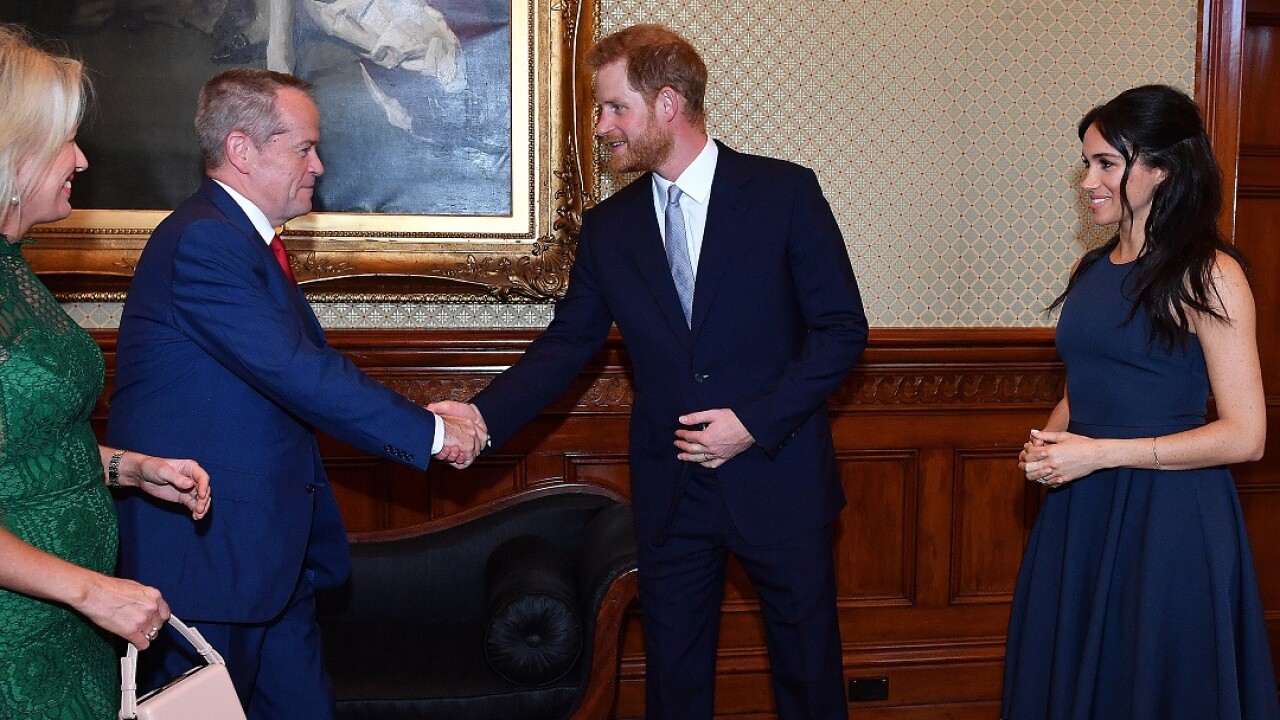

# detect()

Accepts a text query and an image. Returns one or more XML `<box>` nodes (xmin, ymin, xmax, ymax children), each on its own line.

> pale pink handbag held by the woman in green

<box><xmin>120</xmin><ymin>615</ymin><xmax>244</xmax><ymax>720</ymax></box>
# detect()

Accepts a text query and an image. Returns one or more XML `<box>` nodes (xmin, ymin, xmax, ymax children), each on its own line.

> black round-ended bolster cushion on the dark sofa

<box><xmin>484</xmin><ymin>534</ymin><xmax>582</xmax><ymax>685</ymax></box>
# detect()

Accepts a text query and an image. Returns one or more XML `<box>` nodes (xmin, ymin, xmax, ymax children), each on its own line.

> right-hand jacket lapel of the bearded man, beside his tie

<box><xmin>691</xmin><ymin>142</ymin><xmax>751</xmax><ymax>340</ymax></box>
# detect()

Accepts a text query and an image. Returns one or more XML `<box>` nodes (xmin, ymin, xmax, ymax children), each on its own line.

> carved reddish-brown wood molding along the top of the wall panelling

<box><xmin>95</xmin><ymin>328</ymin><xmax>1065</xmax><ymax>414</ymax></box>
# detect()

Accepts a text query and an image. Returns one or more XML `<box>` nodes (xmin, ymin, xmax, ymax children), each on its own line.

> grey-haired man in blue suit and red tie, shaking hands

<box><xmin>108</xmin><ymin>68</ymin><xmax>485</xmax><ymax>720</ymax></box>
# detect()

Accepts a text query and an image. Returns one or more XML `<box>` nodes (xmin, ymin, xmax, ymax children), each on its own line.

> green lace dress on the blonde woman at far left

<box><xmin>0</xmin><ymin>236</ymin><xmax>119</xmax><ymax>720</ymax></box>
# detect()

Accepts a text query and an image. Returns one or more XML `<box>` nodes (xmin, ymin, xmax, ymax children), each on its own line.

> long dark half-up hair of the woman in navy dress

<box><xmin>1050</xmin><ymin>85</ymin><xmax>1248</xmax><ymax>350</ymax></box>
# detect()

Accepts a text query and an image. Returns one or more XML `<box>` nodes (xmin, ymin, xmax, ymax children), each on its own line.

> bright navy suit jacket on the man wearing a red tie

<box><xmin>108</xmin><ymin>179</ymin><xmax>435</xmax><ymax>623</ymax></box>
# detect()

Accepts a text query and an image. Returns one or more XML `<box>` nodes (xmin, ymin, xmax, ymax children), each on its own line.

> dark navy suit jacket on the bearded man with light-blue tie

<box><xmin>474</xmin><ymin>145</ymin><xmax>867</xmax><ymax>543</ymax></box>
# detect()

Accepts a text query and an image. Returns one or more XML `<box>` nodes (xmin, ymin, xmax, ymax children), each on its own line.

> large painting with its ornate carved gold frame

<box><xmin>0</xmin><ymin>0</ymin><xmax>594</xmax><ymax>302</ymax></box>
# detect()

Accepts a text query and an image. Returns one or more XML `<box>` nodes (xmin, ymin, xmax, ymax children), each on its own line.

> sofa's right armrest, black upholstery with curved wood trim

<box><xmin>572</xmin><ymin>503</ymin><xmax>637</xmax><ymax>720</ymax></box>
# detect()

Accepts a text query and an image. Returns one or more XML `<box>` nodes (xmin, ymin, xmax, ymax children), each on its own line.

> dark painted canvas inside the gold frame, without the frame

<box><xmin>0</xmin><ymin>0</ymin><xmax>513</xmax><ymax>215</ymax></box>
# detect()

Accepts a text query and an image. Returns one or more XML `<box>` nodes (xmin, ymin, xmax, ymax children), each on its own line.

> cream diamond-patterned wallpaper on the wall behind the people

<box><xmin>68</xmin><ymin>0</ymin><xmax>1197</xmax><ymax>328</ymax></box>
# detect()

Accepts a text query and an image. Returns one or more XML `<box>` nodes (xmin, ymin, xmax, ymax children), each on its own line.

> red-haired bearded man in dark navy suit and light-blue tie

<box><xmin>430</xmin><ymin>26</ymin><xmax>867</xmax><ymax>720</ymax></box>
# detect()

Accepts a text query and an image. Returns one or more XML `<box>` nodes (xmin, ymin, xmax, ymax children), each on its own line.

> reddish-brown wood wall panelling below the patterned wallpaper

<box><xmin>96</xmin><ymin>326</ymin><xmax>1280</xmax><ymax>720</ymax></box>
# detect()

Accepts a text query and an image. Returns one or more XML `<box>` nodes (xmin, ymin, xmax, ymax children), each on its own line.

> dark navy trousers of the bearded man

<box><xmin>637</xmin><ymin>469</ymin><xmax>849</xmax><ymax>720</ymax></box>
